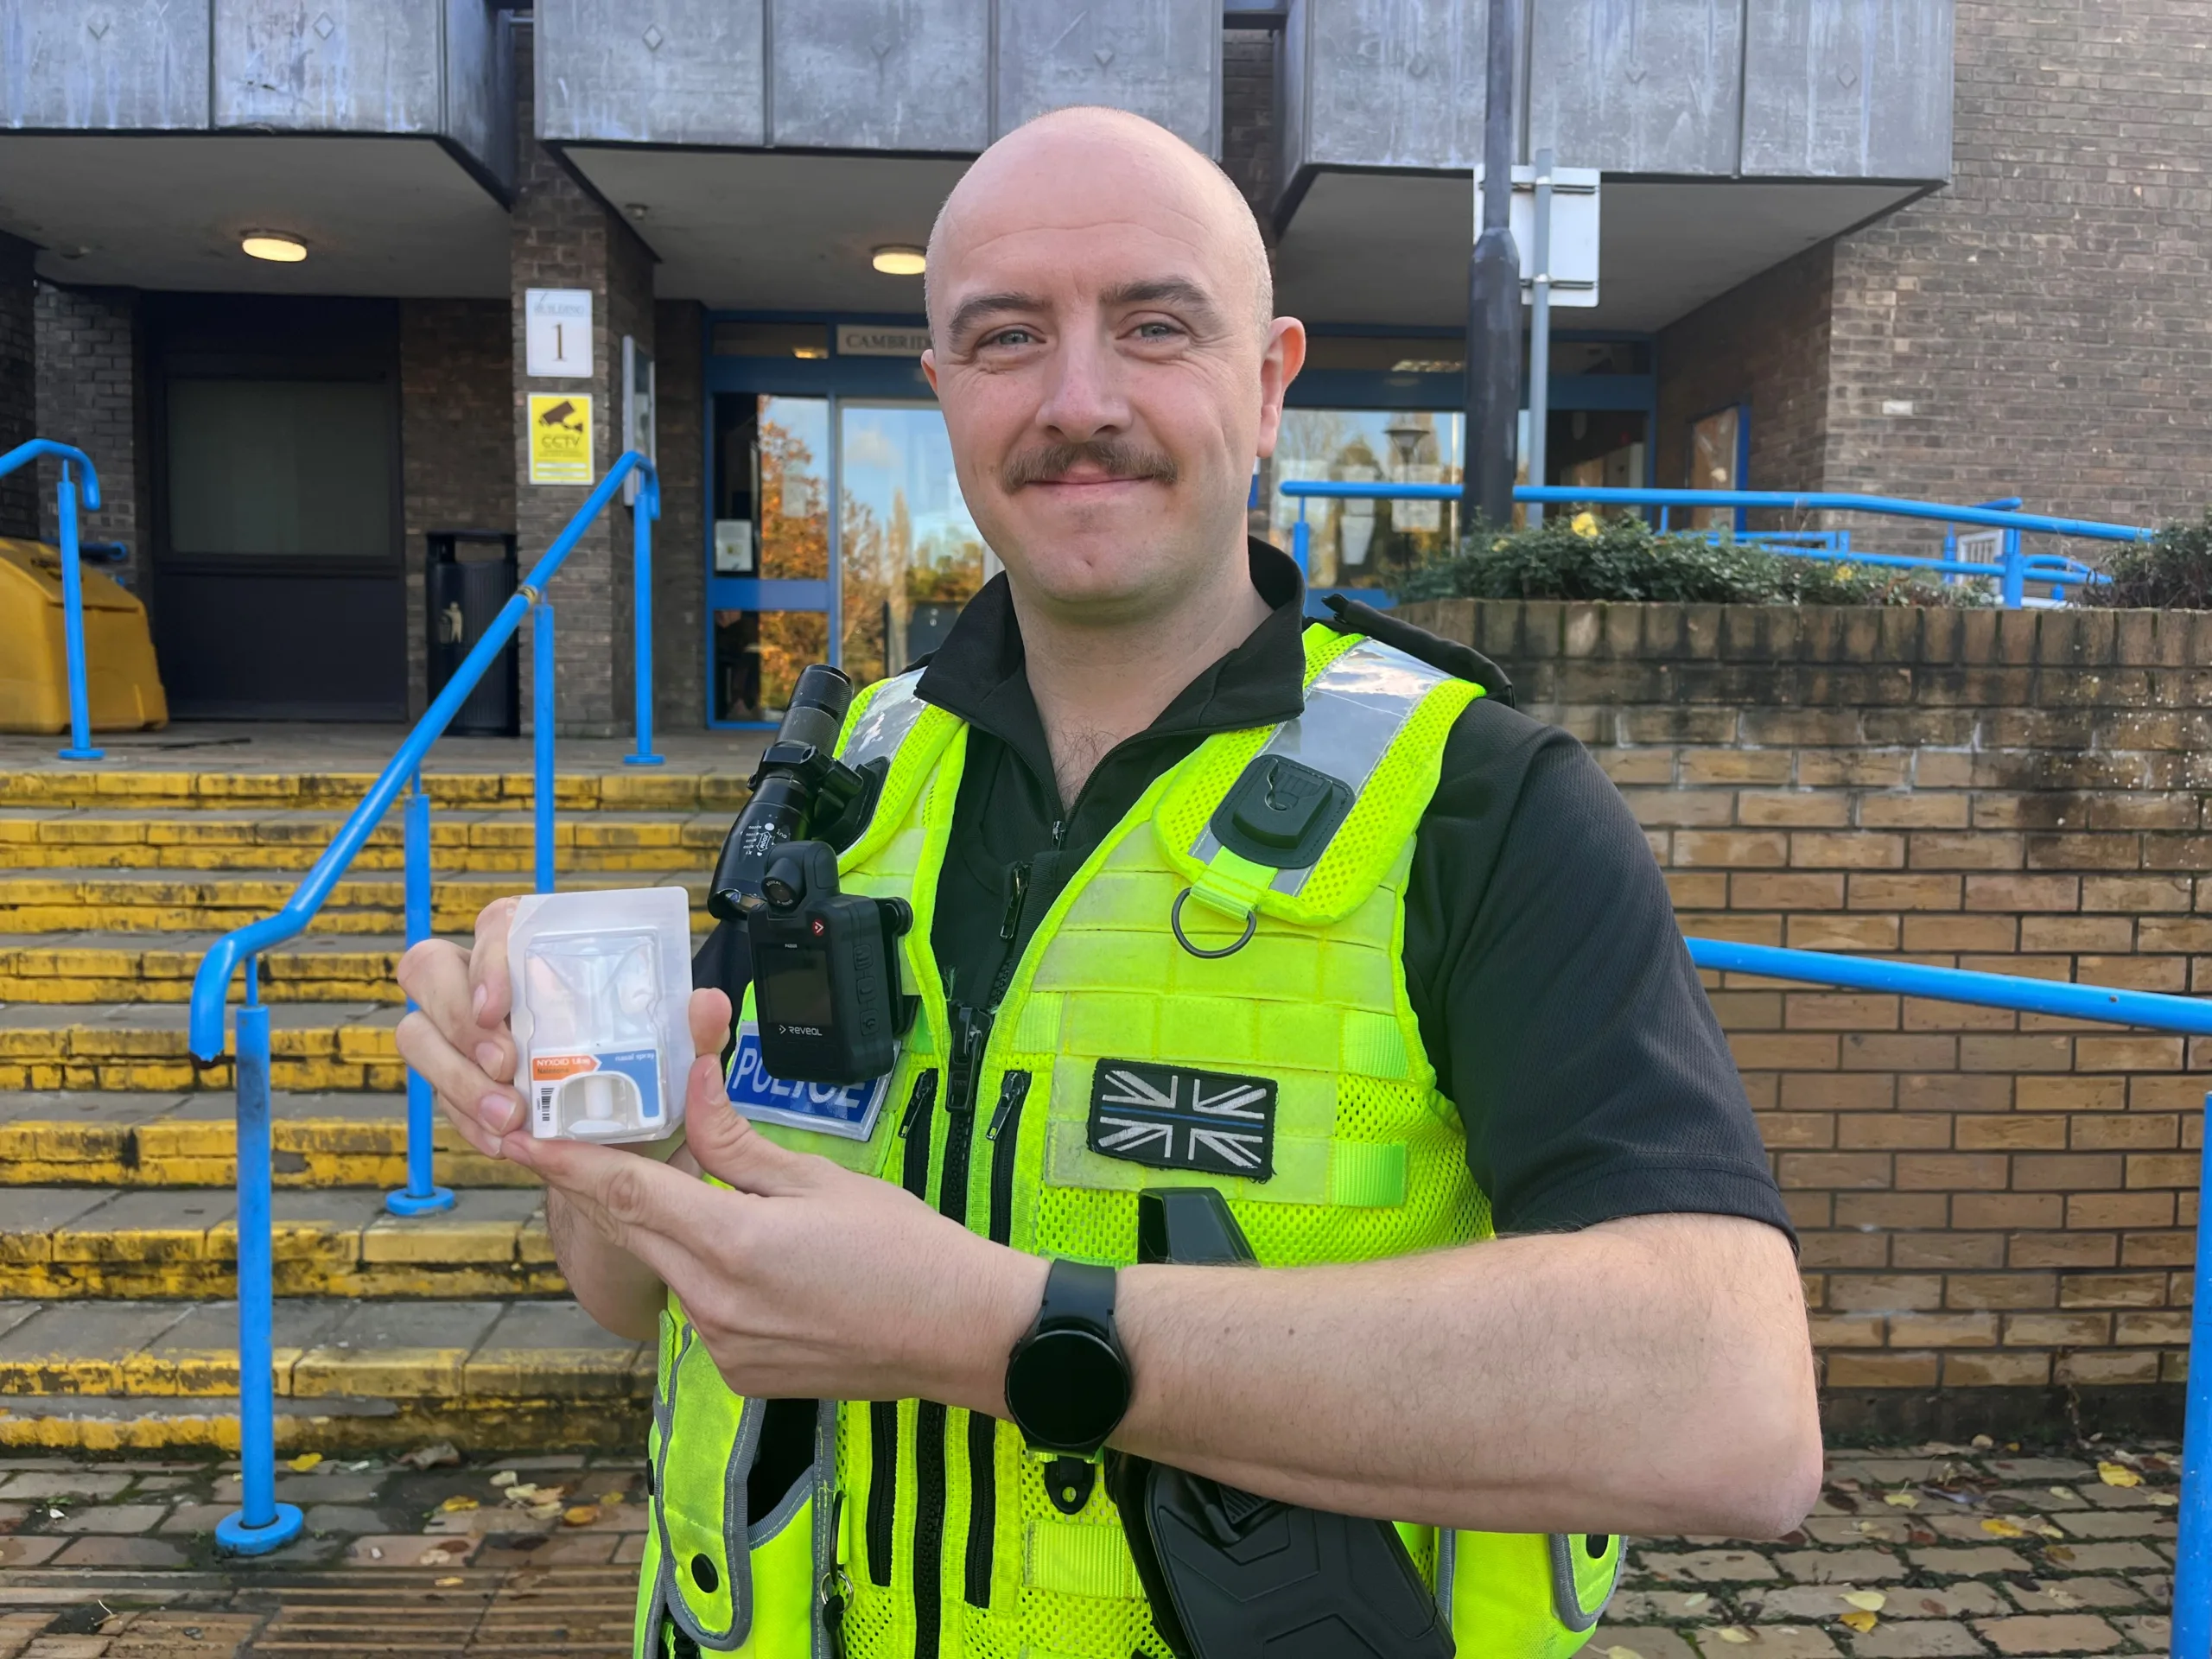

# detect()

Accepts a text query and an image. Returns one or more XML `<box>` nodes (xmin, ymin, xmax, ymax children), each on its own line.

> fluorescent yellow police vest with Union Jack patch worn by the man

<box><xmin>637</xmin><ymin>626</ymin><xmax>1621</xmax><ymax>1659</ymax></box>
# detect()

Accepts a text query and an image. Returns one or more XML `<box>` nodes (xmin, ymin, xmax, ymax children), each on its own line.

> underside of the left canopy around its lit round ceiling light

<box><xmin>0</xmin><ymin>133</ymin><xmax>509</xmax><ymax>299</ymax></box>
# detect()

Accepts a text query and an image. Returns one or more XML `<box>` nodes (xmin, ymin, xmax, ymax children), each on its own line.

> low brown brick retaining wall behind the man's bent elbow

<box><xmin>1409</xmin><ymin>600</ymin><xmax>2212</xmax><ymax>1427</ymax></box>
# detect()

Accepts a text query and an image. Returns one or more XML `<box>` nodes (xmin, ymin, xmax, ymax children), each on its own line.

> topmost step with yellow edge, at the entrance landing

<box><xmin>0</xmin><ymin>769</ymin><xmax>759</xmax><ymax>814</ymax></box>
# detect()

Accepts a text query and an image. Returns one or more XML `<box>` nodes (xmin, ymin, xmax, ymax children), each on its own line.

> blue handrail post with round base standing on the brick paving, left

<box><xmin>214</xmin><ymin>973</ymin><xmax>301</xmax><ymax>1555</ymax></box>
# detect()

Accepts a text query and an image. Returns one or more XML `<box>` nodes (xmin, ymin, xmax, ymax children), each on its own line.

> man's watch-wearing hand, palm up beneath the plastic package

<box><xmin>500</xmin><ymin>1058</ymin><xmax>1046</xmax><ymax>1415</ymax></box>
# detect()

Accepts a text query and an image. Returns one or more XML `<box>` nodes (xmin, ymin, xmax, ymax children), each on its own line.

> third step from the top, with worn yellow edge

<box><xmin>0</xmin><ymin>871</ymin><xmax>712</xmax><ymax>938</ymax></box>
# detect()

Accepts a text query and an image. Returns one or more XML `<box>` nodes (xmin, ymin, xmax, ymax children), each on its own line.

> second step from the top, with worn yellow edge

<box><xmin>0</xmin><ymin>807</ymin><xmax>734</xmax><ymax>876</ymax></box>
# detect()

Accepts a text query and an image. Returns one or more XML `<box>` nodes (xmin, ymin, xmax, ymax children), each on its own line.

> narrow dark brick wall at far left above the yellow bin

<box><xmin>35</xmin><ymin>283</ymin><xmax>143</xmax><ymax>580</ymax></box>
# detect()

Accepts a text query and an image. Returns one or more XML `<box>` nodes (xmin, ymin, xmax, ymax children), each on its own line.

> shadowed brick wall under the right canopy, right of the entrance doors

<box><xmin>1656</xmin><ymin>244</ymin><xmax>1834</xmax><ymax>506</ymax></box>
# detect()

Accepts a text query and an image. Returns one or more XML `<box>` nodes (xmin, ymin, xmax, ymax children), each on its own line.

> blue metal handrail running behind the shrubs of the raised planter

<box><xmin>1276</xmin><ymin>478</ymin><xmax>2157</xmax><ymax>608</ymax></box>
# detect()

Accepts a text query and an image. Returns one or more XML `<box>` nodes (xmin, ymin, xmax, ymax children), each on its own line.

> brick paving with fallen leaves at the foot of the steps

<box><xmin>0</xmin><ymin>1442</ymin><xmax>2179</xmax><ymax>1659</ymax></box>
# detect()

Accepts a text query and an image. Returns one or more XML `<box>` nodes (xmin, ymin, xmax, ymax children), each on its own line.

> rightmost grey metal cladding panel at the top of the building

<box><xmin>1743</xmin><ymin>0</ymin><xmax>1951</xmax><ymax>179</ymax></box>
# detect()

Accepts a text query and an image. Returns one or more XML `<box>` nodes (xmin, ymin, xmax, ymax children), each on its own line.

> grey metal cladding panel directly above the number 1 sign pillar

<box><xmin>533</xmin><ymin>0</ymin><xmax>767</xmax><ymax>146</ymax></box>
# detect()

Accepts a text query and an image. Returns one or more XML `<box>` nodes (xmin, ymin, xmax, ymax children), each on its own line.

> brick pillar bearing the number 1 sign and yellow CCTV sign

<box><xmin>509</xmin><ymin>27</ymin><xmax>652</xmax><ymax>736</ymax></box>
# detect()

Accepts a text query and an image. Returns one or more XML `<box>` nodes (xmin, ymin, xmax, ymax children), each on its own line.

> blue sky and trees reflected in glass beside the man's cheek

<box><xmin>838</xmin><ymin>400</ymin><xmax>984</xmax><ymax>686</ymax></box>
